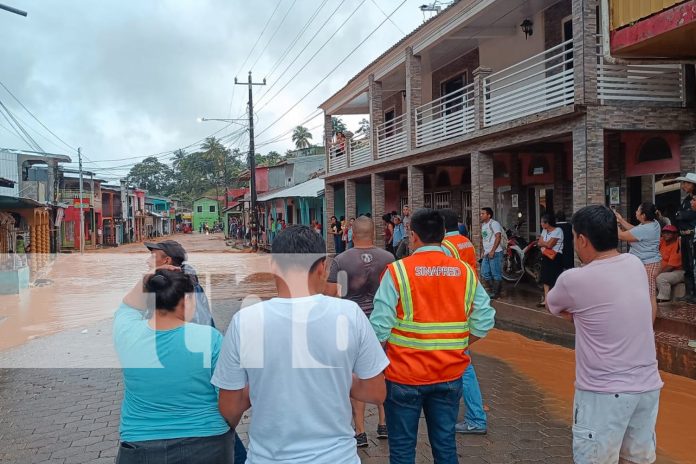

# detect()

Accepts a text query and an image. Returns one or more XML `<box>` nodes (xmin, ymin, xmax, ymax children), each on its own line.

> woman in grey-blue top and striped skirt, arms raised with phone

<box><xmin>614</xmin><ymin>201</ymin><xmax>662</xmax><ymax>320</ymax></box>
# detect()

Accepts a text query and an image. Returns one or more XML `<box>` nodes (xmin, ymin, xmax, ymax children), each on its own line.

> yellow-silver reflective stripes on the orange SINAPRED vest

<box><xmin>389</xmin><ymin>261</ymin><xmax>477</xmax><ymax>351</ymax></box>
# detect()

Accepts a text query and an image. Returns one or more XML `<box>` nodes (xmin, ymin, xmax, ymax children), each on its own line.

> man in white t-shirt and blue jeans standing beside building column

<box><xmin>479</xmin><ymin>208</ymin><xmax>504</xmax><ymax>299</ymax></box>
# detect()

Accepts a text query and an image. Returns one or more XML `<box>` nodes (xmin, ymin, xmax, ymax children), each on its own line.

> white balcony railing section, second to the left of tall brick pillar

<box><xmin>415</xmin><ymin>84</ymin><xmax>475</xmax><ymax>147</ymax></box>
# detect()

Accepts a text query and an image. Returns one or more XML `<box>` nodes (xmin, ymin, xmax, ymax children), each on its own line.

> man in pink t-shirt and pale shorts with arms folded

<box><xmin>546</xmin><ymin>205</ymin><xmax>663</xmax><ymax>464</ymax></box>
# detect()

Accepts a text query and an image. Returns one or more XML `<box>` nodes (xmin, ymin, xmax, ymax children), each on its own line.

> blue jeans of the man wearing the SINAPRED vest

<box><xmin>384</xmin><ymin>379</ymin><xmax>462</xmax><ymax>464</ymax></box>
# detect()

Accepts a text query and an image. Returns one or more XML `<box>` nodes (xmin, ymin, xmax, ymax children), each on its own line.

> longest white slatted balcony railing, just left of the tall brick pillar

<box><xmin>484</xmin><ymin>39</ymin><xmax>575</xmax><ymax>126</ymax></box>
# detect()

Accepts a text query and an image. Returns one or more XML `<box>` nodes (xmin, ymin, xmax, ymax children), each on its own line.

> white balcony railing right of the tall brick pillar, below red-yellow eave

<box><xmin>597</xmin><ymin>37</ymin><xmax>684</xmax><ymax>106</ymax></box>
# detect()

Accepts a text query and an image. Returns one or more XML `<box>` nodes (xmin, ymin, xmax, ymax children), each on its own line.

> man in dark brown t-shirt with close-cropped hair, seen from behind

<box><xmin>324</xmin><ymin>216</ymin><xmax>394</xmax><ymax>447</ymax></box>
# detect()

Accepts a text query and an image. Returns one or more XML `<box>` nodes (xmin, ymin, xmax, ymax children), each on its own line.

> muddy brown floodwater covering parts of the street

<box><xmin>0</xmin><ymin>234</ymin><xmax>696</xmax><ymax>464</ymax></box>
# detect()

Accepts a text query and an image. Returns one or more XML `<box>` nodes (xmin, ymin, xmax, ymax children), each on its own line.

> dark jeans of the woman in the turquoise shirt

<box><xmin>116</xmin><ymin>429</ymin><xmax>246</xmax><ymax>464</ymax></box>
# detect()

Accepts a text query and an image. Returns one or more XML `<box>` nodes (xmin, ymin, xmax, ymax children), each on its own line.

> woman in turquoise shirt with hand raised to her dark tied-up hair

<box><xmin>114</xmin><ymin>269</ymin><xmax>241</xmax><ymax>464</ymax></box>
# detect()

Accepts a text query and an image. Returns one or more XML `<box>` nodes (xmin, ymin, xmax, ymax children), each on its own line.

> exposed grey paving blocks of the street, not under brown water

<box><xmin>0</xmin><ymin>356</ymin><xmax>572</xmax><ymax>464</ymax></box>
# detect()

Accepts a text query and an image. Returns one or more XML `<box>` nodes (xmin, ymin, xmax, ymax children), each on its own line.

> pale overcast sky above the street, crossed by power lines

<box><xmin>0</xmin><ymin>0</ymin><xmax>423</xmax><ymax>178</ymax></box>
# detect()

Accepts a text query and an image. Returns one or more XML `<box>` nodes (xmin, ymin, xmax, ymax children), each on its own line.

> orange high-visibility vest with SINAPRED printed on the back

<box><xmin>384</xmin><ymin>251</ymin><xmax>477</xmax><ymax>385</ymax></box>
